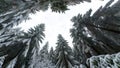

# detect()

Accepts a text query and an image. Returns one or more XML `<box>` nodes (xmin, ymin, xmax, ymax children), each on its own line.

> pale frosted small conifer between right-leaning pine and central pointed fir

<box><xmin>31</xmin><ymin>42</ymin><xmax>55</xmax><ymax>68</ymax></box>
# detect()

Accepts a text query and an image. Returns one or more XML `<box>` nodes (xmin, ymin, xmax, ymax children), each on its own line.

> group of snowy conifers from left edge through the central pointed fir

<box><xmin>0</xmin><ymin>24</ymin><xmax>79</xmax><ymax>68</ymax></box>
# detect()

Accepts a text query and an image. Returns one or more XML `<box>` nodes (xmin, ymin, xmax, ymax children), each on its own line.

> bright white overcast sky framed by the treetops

<box><xmin>19</xmin><ymin>0</ymin><xmax>116</xmax><ymax>49</ymax></box>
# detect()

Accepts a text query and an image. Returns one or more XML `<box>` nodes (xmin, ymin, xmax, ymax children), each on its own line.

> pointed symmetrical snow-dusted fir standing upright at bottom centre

<box><xmin>56</xmin><ymin>35</ymin><xmax>77</xmax><ymax>68</ymax></box>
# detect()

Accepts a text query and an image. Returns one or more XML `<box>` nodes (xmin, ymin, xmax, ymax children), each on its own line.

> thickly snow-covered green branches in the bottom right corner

<box><xmin>87</xmin><ymin>53</ymin><xmax>120</xmax><ymax>68</ymax></box>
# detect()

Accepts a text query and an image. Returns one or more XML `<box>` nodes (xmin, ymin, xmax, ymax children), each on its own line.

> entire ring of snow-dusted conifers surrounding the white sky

<box><xmin>0</xmin><ymin>0</ymin><xmax>120</xmax><ymax>68</ymax></box>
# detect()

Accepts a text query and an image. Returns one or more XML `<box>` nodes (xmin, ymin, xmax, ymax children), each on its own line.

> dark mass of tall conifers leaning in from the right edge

<box><xmin>70</xmin><ymin>0</ymin><xmax>120</xmax><ymax>65</ymax></box>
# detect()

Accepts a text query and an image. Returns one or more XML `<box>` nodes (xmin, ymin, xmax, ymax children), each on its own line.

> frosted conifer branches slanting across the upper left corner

<box><xmin>0</xmin><ymin>0</ymin><xmax>49</xmax><ymax>31</ymax></box>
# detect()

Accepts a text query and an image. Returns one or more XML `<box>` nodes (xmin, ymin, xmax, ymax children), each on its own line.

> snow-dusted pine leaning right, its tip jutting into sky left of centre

<box><xmin>25</xmin><ymin>24</ymin><xmax>45</xmax><ymax>68</ymax></box>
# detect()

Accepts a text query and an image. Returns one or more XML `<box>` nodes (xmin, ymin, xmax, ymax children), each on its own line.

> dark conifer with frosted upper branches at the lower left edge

<box><xmin>0</xmin><ymin>29</ymin><xmax>25</xmax><ymax>68</ymax></box>
